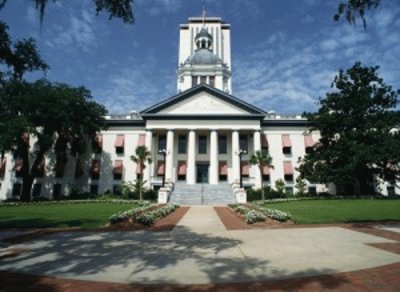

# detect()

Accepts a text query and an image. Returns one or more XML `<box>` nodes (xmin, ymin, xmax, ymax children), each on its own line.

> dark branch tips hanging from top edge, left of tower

<box><xmin>0</xmin><ymin>0</ymin><xmax>135</xmax><ymax>24</ymax></box>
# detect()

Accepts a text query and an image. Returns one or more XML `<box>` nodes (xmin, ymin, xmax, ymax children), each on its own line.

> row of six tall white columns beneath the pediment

<box><xmin>144</xmin><ymin>129</ymin><xmax>261</xmax><ymax>187</ymax></box>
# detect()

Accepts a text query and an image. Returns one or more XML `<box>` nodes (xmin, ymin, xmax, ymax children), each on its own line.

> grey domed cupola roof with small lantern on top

<box><xmin>185</xmin><ymin>27</ymin><xmax>222</xmax><ymax>65</ymax></box>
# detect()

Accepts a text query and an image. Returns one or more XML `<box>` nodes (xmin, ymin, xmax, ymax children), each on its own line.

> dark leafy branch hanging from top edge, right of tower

<box><xmin>333</xmin><ymin>0</ymin><xmax>381</xmax><ymax>28</ymax></box>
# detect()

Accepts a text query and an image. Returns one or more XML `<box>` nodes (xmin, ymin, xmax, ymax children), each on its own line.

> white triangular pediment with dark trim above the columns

<box><xmin>141</xmin><ymin>85</ymin><xmax>265</xmax><ymax>116</ymax></box>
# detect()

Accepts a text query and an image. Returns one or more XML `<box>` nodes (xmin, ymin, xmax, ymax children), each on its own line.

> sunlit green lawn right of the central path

<box><xmin>266</xmin><ymin>199</ymin><xmax>400</xmax><ymax>224</ymax></box>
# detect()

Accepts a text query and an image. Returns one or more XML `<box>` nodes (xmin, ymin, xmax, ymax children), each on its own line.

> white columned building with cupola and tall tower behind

<box><xmin>0</xmin><ymin>17</ymin><xmax>395</xmax><ymax>199</ymax></box>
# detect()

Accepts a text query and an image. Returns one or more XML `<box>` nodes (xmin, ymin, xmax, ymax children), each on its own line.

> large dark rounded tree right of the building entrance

<box><xmin>299</xmin><ymin>63</ymin><xmax>400</xmax><ymax>195</ymax></box>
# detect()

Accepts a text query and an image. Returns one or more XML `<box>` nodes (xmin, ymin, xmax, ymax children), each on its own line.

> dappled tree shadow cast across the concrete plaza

<box><xmin>0</xmin><ymin>227</ymin><xmax>346</xmax><ymax>289</ymax></box>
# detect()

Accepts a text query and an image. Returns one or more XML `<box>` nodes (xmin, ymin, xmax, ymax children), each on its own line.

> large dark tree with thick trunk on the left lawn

<box><xmin>0</xmin><ymin>23</ymin><xmax>106</xmax><ymax>201</ymax></box>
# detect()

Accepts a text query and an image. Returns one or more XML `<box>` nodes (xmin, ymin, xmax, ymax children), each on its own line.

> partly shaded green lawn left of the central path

<box><xmin>0</xmin><ymin>202</ymin><xmax>135</xmax><ymax>228</ymax></box>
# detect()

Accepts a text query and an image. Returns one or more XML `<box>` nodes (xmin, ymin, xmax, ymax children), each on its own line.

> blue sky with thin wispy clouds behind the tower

<box><xmin>0</xmin><ymin>0</ymin><xmax>400</xmax><ymax>114</ymax></box>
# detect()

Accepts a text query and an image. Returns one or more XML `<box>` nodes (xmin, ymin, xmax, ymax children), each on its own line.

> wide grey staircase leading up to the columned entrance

<box><xmin>169</xmin><ymin>182</ymin><xmax>236</xmax><ymax>206</ymax></box>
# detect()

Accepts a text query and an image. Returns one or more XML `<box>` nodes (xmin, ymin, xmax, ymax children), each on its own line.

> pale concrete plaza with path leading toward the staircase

<box><xmin>0</xmin><ymin>207</ymin><xmax>400</xmax><ymax>284</ymax></box>
